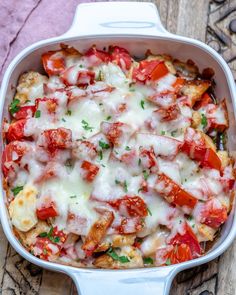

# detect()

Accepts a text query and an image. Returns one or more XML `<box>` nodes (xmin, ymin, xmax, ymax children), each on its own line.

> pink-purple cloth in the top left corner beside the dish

<box><xmin>0</xmin><ymin>0</ymin><xmax>96</xmax><ymax>81</ymax></box>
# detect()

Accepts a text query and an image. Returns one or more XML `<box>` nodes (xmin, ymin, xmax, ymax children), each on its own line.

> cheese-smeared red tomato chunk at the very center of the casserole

<box><xmin>101</xmin><ymin>122</ymin><xmax>125</xmax><ymax>145</ymax></box>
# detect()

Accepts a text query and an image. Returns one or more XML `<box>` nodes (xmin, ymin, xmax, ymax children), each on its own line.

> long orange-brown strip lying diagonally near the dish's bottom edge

<box><xmin>82</xmin><ymin>210</ymin><xmax>114</xmax><ymax>256</ymax></box>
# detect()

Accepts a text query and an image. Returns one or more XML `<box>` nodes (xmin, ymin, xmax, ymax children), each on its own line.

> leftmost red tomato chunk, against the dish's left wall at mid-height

<box><xmin>2</xmin><ymin>141</ymin><xmax>27</xmax><ymax>177</ymax></box>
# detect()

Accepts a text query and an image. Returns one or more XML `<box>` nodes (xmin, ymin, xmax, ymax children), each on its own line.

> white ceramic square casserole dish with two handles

<box><xmin>0</xmin><ymin>2</ymin><xmax>236</xmax><ymax>295</ymax></box>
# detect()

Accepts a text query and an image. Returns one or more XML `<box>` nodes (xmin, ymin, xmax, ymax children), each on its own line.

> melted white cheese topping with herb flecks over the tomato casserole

<box><xmin>5</xmin><ymin>45</ymin><xmax>233</xmax><ymax>267</ymax></box>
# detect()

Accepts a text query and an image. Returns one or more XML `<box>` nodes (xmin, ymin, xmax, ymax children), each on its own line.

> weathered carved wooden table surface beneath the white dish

<box><xmin>0</xmin><ymin>0</ymin><xmax>236</xmax><ymax>295</ymax></box>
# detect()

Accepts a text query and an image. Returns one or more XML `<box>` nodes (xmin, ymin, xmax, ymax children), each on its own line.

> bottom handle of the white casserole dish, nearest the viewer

<box><xmin>68</xmin><ymin>267</ymin><xmax>175</xmax><ymax>295</ymax></box>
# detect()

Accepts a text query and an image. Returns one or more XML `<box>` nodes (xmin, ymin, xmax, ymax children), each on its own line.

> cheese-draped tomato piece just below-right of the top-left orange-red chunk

<box><xmin>60</xmin><ymin>66</ymin><xmax>95</xmax><ymax>87</ymax></box>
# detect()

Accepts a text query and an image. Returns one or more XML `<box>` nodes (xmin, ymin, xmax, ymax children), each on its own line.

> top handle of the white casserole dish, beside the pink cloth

<box><xmin>63</xmin><ymin>2</ymin><xmax>170</xmax><ymax>37</ymax></box>
